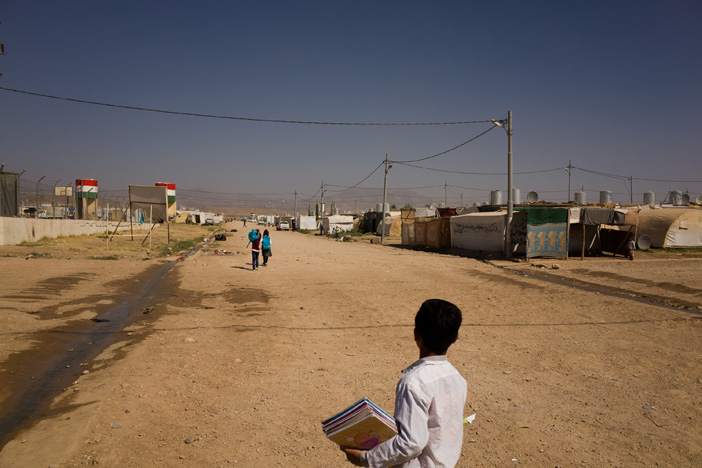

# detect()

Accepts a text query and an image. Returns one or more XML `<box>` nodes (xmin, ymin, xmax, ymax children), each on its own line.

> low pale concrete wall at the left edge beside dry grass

<box><xmin>0</xmin><ymin>217</ymin><xmax>129</xmax><ymax>245</ymax></box>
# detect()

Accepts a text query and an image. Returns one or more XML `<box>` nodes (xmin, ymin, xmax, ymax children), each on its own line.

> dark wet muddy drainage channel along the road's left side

<box><xmin>0</xmin><ymin>262</ymin><xmax>179</xmax><ymax>449</ymax></box>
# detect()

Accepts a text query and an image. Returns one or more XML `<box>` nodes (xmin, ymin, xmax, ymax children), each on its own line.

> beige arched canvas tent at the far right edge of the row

<box><xmin>636</xmin><ymin>208</ymin><xmax>702</xmax><ymax>248</ymax></box>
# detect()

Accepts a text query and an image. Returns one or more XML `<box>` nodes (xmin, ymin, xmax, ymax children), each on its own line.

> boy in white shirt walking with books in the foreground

<box><xmin>341</xmin><ymin>299</ymin><xmax>467</xmax><ymax>468</ymax></box>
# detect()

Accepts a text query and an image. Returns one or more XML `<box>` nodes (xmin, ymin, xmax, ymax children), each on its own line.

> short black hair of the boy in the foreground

<box><xmin>414</xmin><ymin>299</ymin><xmax>463</xmax><ymax>354</ymax></box>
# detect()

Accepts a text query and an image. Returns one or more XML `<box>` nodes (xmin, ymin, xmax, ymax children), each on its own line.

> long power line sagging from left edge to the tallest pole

<box><xmin>0</xmin><ymin>86</ymin><xmax>491</xmax><ymax>126</ymax></box>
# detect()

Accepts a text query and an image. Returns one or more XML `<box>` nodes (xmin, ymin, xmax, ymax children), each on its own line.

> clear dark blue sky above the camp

<box><xmin>0</xmin><ymin>0</ymin><xmax>702</xmax><ymax>205</ymax></box>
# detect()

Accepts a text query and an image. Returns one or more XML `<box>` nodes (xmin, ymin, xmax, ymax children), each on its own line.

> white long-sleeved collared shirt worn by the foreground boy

<box><xmin>363</xmin><ymin>355</ymin><xmax>467</xmax><ymax>468</ymax></box>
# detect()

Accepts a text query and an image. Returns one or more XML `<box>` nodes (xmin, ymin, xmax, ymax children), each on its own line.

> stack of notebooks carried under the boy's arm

<box><xmin>322</xmin><ymin>398</ymin><xmax>397</xmax><ymax>450</ymax></box>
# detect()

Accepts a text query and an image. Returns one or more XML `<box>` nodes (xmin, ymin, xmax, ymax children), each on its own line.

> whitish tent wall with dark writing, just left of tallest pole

<box><xmin>451</xmin><ymin>212</ymin><xmax>506</xmax><ymax>252</ymax></box>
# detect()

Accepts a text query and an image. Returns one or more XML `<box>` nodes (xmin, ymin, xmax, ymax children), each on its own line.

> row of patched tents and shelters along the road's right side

<box><xmin>402</xmin><ymin>206</ymin><xmax>702</xmax><ymax>258</ymax></box>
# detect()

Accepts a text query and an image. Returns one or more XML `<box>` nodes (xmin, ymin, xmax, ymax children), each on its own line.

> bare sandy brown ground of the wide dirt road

<box><xmin>0</xmin><ymin>223</ymin><xmax>702</xmax><ymax>468</ymax></box>
